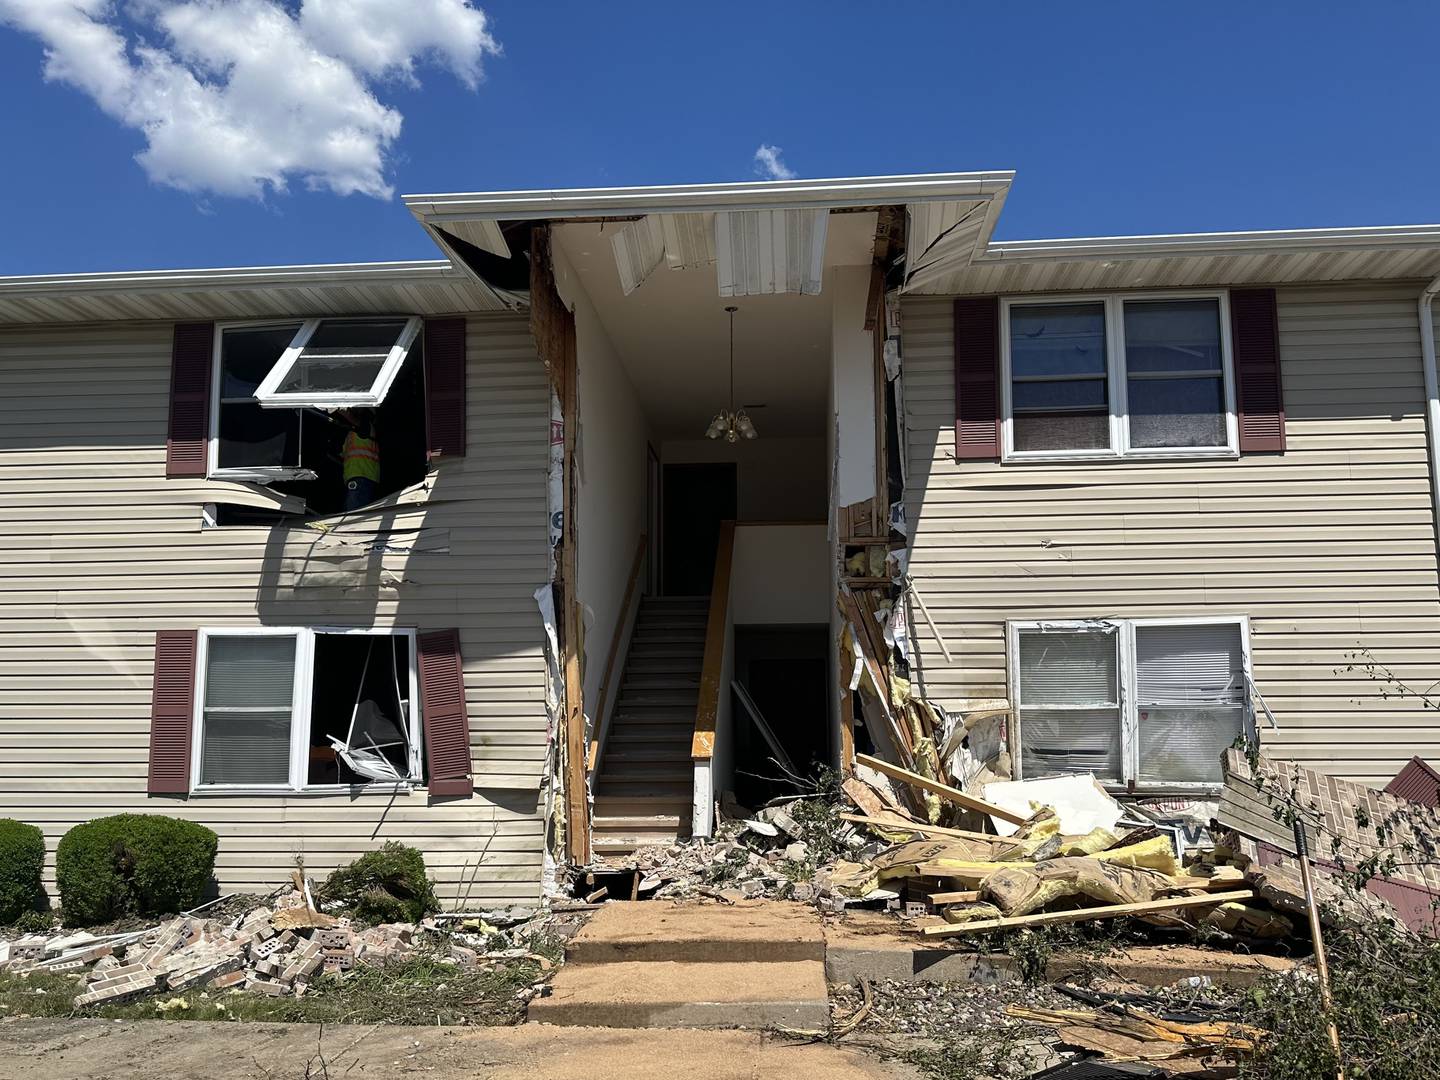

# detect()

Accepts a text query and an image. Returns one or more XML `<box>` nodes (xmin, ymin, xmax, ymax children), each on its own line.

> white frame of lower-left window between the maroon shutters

<box><xmin>190</xmin><ymin>626</ymin><xmax>425</xmax><ymax>795</ymax></box>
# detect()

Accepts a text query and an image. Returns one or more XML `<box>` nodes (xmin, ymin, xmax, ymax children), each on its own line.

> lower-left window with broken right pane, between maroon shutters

<box><xmin>193</xmin><ymin>629</ymin><xmax>422</xmax><ymax>791</ymax></box>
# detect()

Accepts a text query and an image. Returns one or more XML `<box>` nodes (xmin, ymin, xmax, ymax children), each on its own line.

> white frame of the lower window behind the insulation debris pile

<box><xmin>1005</xmin><ymin>615</ymin><xmax>1259</xmax><ymax>795</ymax></box>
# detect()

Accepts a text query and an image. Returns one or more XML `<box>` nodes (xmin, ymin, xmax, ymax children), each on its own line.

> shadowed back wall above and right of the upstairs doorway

<box><xmin>660</xmin><ymin>440</ymin><xmax>829</xmax><ymax>521</ymax></box>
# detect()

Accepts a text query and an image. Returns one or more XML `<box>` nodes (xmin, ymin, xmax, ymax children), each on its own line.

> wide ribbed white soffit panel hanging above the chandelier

<box><xmin>716</xmin><ymin>207</ymin><xmax>829</xmax><ymax>297</ymax></box>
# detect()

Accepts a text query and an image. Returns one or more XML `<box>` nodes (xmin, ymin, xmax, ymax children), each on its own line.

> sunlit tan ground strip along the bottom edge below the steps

<box><xmin>0</xmin><ymin>1020</ymin><xmax>917</xmax><ymax>1080</ymax></box>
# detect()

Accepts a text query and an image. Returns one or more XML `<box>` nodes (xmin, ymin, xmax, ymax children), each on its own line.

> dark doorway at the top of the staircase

<box><xmin>661</xmin><ymin>461</ymin><xmax>739</xmax><ymax>596</ymax></box>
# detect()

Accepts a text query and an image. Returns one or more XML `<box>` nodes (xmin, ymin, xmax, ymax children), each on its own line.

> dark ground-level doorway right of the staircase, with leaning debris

<box><xmin>730</xmin><ymin>625</ymin><xmax>831</xmax><ymax>806</ymax></box>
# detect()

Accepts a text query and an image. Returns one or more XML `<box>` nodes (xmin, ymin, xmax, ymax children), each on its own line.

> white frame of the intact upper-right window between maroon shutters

<box><xmin>999</xmin><ymin>289</ymin><xmax>1240</xmax><ymax>462</ymax></box>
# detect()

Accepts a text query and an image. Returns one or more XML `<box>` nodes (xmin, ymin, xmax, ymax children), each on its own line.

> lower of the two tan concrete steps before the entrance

<box><xmin>530</xmin><ymin>960</ymin><xmax>829</xmax><ymax>1030</ymax></box>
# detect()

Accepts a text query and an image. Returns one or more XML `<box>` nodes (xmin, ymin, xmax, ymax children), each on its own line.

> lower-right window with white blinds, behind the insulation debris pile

<box><xmin>1011</xmin><ymin>618</ymin><xmax>1253</xmax><ymax>789</ymax></box>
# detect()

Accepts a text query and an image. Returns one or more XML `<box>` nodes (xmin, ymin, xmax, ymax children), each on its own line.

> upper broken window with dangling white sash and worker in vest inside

<box><xmin>210</xmin><ymin>317</ymin><xmax>426</xmax><ymax>524</ymax></box>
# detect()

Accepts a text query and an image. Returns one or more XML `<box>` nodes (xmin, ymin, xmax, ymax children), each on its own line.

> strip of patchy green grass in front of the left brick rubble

<box><xmin>0</xmin><ymin>950</ymin><xmax>541</xmax><ymax>1025</ymax></box>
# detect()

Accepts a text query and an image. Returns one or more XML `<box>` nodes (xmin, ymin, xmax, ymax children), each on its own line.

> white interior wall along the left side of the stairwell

<box><xmin>554</xmin><ymin>245</ymin><xmax>649</xmax><ymax>724</ymax></box>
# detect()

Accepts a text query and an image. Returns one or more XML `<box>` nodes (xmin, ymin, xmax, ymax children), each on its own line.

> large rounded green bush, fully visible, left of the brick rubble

<box><xmin>55</xmin><ymin>814</ymin><xmax>220</xmax><ymax>926</ymax></box>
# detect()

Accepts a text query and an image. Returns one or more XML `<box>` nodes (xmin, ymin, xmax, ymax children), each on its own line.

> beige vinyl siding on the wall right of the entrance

<box><xmin>903</xmin><ymin>284</ymin><xmax>1440</xmax><ymax>783</ymax></box>
